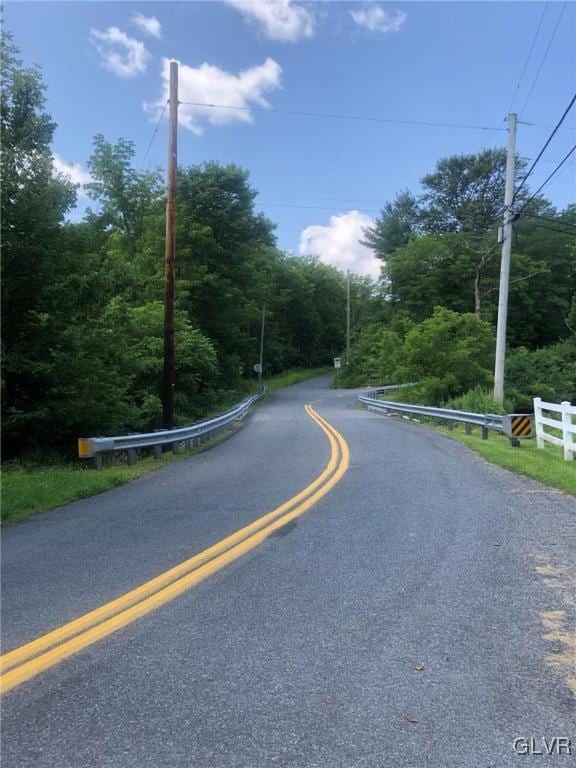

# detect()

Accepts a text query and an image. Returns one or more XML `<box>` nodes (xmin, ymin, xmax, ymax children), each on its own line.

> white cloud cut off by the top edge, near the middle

<box><xmin>226</xmin><ymin>0</ymin><xmax>314</xmax><ymax>43</ymax></box>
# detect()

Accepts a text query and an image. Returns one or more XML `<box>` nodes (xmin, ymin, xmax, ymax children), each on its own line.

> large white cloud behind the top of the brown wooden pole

<box><xmin>144</xmin><ymin>59</ymin><xmax>282</xmax><ymax>135</ymax></box>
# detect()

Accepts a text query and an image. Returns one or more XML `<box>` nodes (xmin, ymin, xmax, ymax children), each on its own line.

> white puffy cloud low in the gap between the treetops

<box><xmin>298</xmin><ymin>211</ymin><xmax>382</xmax><ymax>278</ymax></box>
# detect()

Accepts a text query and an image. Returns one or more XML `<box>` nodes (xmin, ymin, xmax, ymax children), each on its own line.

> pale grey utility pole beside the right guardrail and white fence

<box><xmin>494</xmin><ymin>113</ymin><xmax>517</xmax><ymax>403</ymax></box>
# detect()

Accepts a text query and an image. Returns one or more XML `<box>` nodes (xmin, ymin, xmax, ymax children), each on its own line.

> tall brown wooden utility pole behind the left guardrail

<box><xmin>162</xmin><ymin>61</ymin><xmax>178</xmax><ymax>429</ymax></box>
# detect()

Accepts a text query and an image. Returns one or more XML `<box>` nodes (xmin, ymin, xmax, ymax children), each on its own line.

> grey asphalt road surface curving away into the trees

<box><xmin>2</xmin><ymin>377</ymin><xmax>576</xmax><ymax>768</ymax></box>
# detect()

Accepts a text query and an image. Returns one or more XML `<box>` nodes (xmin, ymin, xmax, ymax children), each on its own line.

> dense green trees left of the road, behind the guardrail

<box><xmin>1</xmin><ymin>37</ymin><xmax>373</xmax><ymax>456</ymax></box>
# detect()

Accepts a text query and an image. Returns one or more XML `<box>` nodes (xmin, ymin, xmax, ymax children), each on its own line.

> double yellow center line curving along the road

<box><xmin>0</xmin><ymin>405</ymin><xmax>350</xmax><ymax>693</ymax></box>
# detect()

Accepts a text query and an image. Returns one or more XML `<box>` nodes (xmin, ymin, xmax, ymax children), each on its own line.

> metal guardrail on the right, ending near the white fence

<box><xmin>358</xmin><ymin>384</ymin><xmax>510</xmax><ymax>439</ymax></box>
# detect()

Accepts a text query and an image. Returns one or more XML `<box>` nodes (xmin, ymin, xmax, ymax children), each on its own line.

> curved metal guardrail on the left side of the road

<box><xmin>78</xmin><ymin>387</ymin><xmax>266</xmax><ymax>469</ymax></box>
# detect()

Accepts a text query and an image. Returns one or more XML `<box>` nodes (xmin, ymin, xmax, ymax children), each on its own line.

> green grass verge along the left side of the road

<box><xmin>1</xmin><ymin>368</ymin><xmax>331</xmax><ymax>525</ymax></box>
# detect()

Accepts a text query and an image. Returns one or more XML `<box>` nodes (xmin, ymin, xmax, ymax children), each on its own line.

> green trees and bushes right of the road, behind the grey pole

<box><xmin>340</xmin><ymin>144</ymin><xmax>576</xmax><ymax>410</ymax></box>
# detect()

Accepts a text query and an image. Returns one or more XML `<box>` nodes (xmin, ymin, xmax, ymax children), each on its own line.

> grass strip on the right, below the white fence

<box><xmin>414</xmin><ymin>416</ymin><xmax>576</xmax><ymax>496</ymax></box>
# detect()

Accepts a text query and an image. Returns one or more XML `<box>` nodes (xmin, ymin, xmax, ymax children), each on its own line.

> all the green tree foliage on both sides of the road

<box><xmin>0</xmin><ymin>34</ymin><xmax>576</xmax><ymax>457</ymax></box>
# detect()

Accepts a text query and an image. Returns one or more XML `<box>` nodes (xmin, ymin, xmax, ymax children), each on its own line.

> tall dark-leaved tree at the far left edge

<box><xmin>0</xmin><ymin>33</ymin><xmax>76</xmax><ymax>456</ymax></box>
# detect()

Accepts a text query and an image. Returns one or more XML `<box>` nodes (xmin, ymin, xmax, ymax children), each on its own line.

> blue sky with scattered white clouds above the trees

<box><xmin>4</xmin><ymin>0</ymin><xmax>576</xmax><ymax>276</ymax></box>
